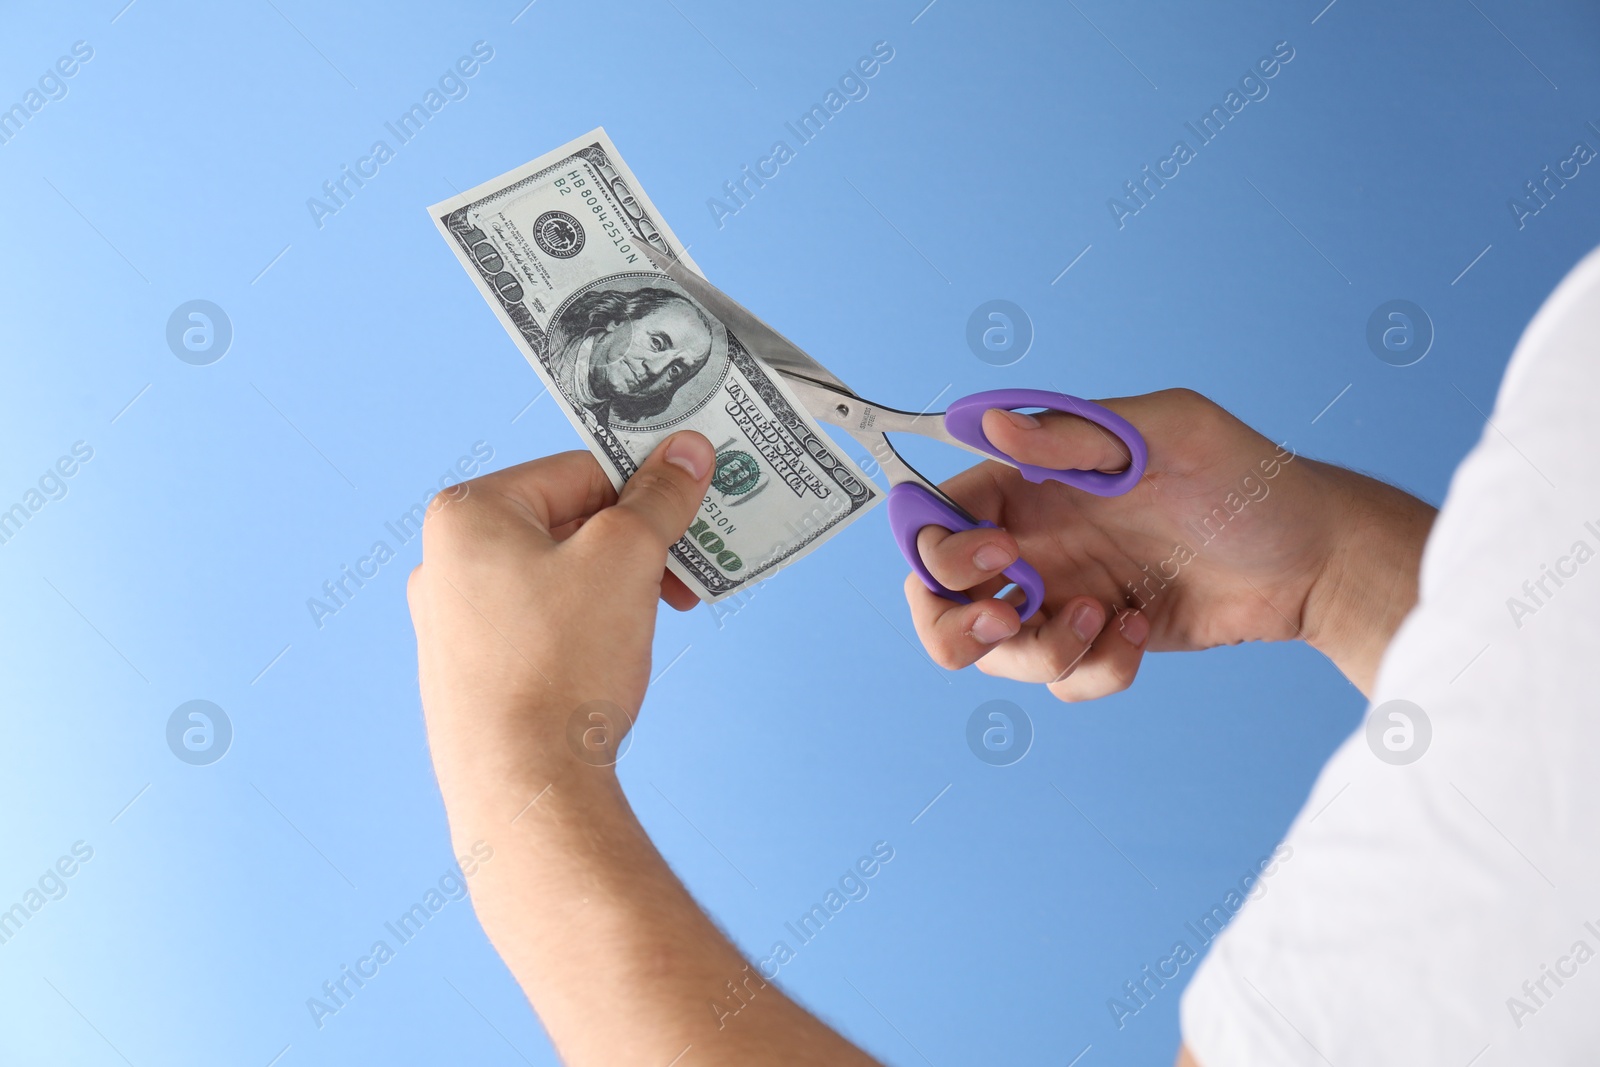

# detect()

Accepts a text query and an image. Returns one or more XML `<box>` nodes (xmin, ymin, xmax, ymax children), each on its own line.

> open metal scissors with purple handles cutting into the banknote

<box><xmin>643</xmin><ymin>243</ymin><xmax>1149</xmax><ymax>619</ymax></box>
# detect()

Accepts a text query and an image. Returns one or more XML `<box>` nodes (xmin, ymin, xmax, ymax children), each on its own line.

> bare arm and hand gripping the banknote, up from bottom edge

<box><xmin>406</xmin><ymin>430</ymin><xmax>872</xmax><ymax>1067</ymax></box>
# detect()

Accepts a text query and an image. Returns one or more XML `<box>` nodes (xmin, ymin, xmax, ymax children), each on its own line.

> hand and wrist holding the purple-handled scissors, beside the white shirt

<box><xmin>906</xmin><ymin>389</ymin><xmax>1434</xmax><ymax>701</ymax></box>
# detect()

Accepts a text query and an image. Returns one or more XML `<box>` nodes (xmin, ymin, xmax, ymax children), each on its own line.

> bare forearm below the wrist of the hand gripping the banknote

<box><xmin>450</xmin><ymin>761</ymin><xmax>874</xmax><ymax>1067</ymax></box>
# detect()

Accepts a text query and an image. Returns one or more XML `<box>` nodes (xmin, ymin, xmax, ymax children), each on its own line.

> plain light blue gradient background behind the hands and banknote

<box><xmin>0</xmin><ymin>0</ymin><xmax>1600</xmax><ymax>1067</ymax></box>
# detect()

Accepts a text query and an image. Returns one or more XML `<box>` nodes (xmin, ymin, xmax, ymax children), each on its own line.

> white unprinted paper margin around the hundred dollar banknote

<box><xmin>427</xmin><ymin>126</ymin><xmax>885</xmax><ymax>603</ymax></box>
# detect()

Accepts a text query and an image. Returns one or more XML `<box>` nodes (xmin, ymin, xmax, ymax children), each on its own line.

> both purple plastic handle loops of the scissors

<box><xmin>890</xmin><ymin>389</ymin><xmax>1149</xmax><ymax>619</ymax></box>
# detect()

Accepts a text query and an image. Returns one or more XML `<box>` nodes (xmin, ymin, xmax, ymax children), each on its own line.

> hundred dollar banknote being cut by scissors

<box><xmin>429</xmin><ymin>130</ymin><xmax>882</xmax><ymax>601</ymax></box>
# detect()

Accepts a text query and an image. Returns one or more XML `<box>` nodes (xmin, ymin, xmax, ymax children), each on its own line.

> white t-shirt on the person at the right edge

<box><xmin>1181</xmin><ymin>250</ymin><xmax>1600</xmax><ymax>1067</ymax></box>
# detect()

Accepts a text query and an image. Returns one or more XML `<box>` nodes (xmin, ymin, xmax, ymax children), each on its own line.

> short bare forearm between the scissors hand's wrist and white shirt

<box><xmin>1302</xmin><ymin>464</ymin><xmax>1437</xmax><ymax>696</ymax></box>
